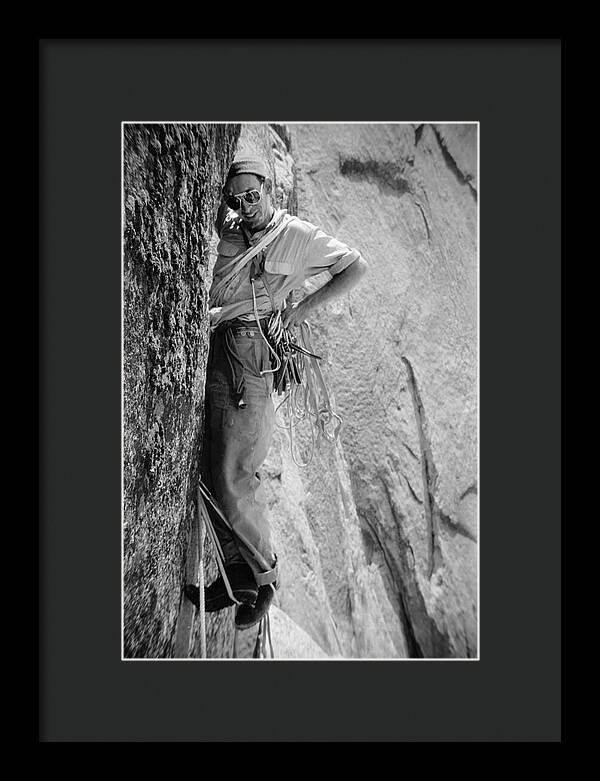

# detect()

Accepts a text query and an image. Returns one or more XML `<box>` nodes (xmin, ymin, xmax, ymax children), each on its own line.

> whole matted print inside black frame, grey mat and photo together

<box><xmin>39</xmin><ymin>39</ymin><xmax>561</xmax><ymax>742</ymax></box>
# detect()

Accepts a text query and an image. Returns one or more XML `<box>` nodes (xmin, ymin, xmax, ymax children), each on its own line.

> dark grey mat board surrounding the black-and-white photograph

<box><xmin>38</xmin><ymin>38</ymin><xmax>561</xmax><ymax>742</ymax></box>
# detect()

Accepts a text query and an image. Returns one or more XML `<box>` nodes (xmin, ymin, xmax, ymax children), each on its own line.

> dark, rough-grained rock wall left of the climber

<box><xmin>123</xmin><ymin>124</ymin><xmax>240</xmax><ymax>658</ymax></box>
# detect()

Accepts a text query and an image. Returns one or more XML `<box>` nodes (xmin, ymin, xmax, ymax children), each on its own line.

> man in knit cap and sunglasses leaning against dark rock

<box><xmin>185</xmin><ymin>157</ymin><xmax>367</xmax><ymax>629</ymax></box>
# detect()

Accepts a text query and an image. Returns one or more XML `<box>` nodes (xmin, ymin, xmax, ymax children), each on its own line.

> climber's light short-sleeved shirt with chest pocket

<box><xmin>209</xmin><ymin>209</ymin><xmax>360</xmax><ymax>328</ymax></box>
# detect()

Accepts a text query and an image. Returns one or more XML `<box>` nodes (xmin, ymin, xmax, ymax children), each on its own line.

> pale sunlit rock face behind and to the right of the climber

<box><xmin>217</xmin><ymin>125</ymin><xmax>477</xmax><ymax>658</ymax></box>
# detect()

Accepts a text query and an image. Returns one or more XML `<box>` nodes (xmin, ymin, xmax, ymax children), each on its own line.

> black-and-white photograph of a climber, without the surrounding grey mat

<box><xmin>121</xmin><ymin>118</ymin><xmax>480</xmax><ymax>661</ymax></box>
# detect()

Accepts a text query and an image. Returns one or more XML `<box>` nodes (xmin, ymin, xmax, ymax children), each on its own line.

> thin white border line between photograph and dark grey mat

<box><xmin>120</xmin><ymin>119</ymin><xmax>481</xmax><ymax>662</ymax></box>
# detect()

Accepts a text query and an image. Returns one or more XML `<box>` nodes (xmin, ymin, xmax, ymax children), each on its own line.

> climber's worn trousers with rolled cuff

<box><xmin>202</xmin><ymin>321</ymin><xmax>276</xmax><ymax>585</ymax></box>
